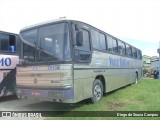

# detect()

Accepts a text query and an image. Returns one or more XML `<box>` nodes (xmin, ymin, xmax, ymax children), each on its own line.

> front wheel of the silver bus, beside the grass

<box><xmin>91</xmin><ymin>79</ymin><xmax>103</xmax><ymax>103</ymax></box>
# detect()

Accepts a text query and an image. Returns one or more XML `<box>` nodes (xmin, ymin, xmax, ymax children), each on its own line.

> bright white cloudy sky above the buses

<box><xmin>0</xmin><ymin>0</ymin><xmax>160</xmax><ymax>56</ymax></box>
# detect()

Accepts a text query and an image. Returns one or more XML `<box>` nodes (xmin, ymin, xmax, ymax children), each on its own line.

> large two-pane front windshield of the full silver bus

<box><xmin>20</xmin><ymin>23</ymin><xmax>70</xmax><ymax>62</ymax></box>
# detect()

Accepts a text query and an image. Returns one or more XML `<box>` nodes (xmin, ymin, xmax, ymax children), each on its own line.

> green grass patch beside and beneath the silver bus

<box><xmin>46</xmin><ymin>78</ymin><xmax>160</xmax><ymax>120</ymax></box>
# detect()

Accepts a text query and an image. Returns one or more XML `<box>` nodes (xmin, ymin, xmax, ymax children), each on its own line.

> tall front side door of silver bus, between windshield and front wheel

<box><xmin>74</xmin><ymin>23</ymin><xmax>91</xmax><ymax>101</ymax></box>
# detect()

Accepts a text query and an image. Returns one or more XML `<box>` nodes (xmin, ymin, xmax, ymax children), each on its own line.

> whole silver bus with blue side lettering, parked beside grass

<box><xmin>16</xmin><ymin>19</ymin><xmax>142</xmax><ymax>103</ymax></box>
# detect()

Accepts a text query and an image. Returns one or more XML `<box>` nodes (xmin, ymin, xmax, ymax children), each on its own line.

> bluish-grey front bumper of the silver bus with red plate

<box><xmin>16</xmin><ymin>87</ymin><xmax>74</xmax><ymax>102</ymax></box>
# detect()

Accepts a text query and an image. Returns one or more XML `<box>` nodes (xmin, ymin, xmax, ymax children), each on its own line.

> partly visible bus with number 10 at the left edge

<box><xmin>0</xmin><ymin>31</ymin><xmax>20</xmax><ymax>97</ymax></box>
